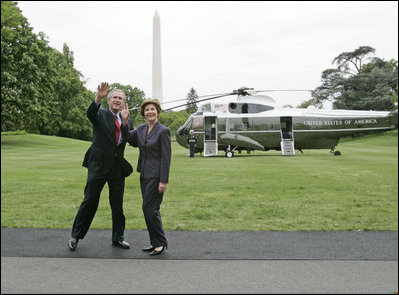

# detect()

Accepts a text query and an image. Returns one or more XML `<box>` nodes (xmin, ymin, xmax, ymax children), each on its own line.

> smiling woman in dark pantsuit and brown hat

<box><xmin>127</xmin><ymin>99</ymin><xmax>171</xmax><ymax>256</ymax></box>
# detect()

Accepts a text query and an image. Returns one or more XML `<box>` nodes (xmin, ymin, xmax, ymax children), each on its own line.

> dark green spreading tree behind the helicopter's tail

<box><xmin>312</xmin><ymin>46</ymin><xmax>398</xmax><ymax>110</ymax></box>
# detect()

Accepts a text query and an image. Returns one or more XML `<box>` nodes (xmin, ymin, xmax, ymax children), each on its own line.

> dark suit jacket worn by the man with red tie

<box><xmin>83</xmin><ymin>101</ymin><xmax>133</xmax><ymax>177</ymax></box>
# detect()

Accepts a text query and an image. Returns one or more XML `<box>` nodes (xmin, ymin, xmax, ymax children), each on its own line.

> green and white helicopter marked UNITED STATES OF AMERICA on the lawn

<box><xmin>166</xmin><ymin>87</ymin><xmax>398</xmax><ymax>158</ymax></box>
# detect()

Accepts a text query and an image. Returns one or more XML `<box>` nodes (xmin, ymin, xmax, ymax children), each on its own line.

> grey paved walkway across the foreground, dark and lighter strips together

<box><xmin>1</xmin><ymin>228</ymin><xmax>398</xmax><ymax>294</ymax></box>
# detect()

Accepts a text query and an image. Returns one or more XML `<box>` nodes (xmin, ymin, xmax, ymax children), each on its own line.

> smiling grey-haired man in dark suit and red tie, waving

<box><xmin>68</xmin><ymin>83</ymin><xmax>133</xmax><ymax>251</ymax></box>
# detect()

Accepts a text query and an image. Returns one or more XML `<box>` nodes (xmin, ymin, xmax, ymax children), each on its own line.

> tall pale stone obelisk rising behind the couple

<box><xmin>152</xmin><ymin>10</ymin><xmax>163</xmax><ymax>104</ymax></box>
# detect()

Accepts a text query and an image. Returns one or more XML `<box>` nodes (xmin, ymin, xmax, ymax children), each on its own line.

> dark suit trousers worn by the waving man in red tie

<box><xmin>72</xmin><ymin>164</ymin><xmax>125</xmax><ymax>241</ymax></box>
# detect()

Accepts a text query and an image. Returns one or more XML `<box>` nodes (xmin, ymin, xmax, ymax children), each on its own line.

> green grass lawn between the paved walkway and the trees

<box><xmin>1</xmin><ymin>131</ymin><xmax>398</xmax><ymax>231</ymax></box>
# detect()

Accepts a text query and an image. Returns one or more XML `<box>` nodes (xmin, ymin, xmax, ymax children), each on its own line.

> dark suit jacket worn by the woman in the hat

<box><xmin>127</xmin><ymin>122</ymin><xmax>172</xmax><ymax>183</ymax></box>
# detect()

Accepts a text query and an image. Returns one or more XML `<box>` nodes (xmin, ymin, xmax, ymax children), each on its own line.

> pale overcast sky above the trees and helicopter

<box><xmin>18</xmin><ymin>1</ymin><xmax>398</xmax><ymax>106</ymax></box>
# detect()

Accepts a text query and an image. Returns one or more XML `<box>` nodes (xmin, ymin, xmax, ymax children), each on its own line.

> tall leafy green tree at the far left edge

<box><xmin>1</xmin><ymin>1</ymin><xmax>49</xmax><ymax>130</ymax></box>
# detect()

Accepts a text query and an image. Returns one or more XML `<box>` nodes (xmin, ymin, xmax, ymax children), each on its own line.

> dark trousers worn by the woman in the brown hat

<box><xmin>140</xmin><ymin>177</ymin><xmax>168</xmax><ymax>247</ymax></box>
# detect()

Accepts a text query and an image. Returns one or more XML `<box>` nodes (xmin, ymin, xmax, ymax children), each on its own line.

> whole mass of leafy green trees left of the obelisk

<box><xmin>1</xmin><ymin>1</ymin><xmax>148</xmax><ymax>139</ymax></box>
